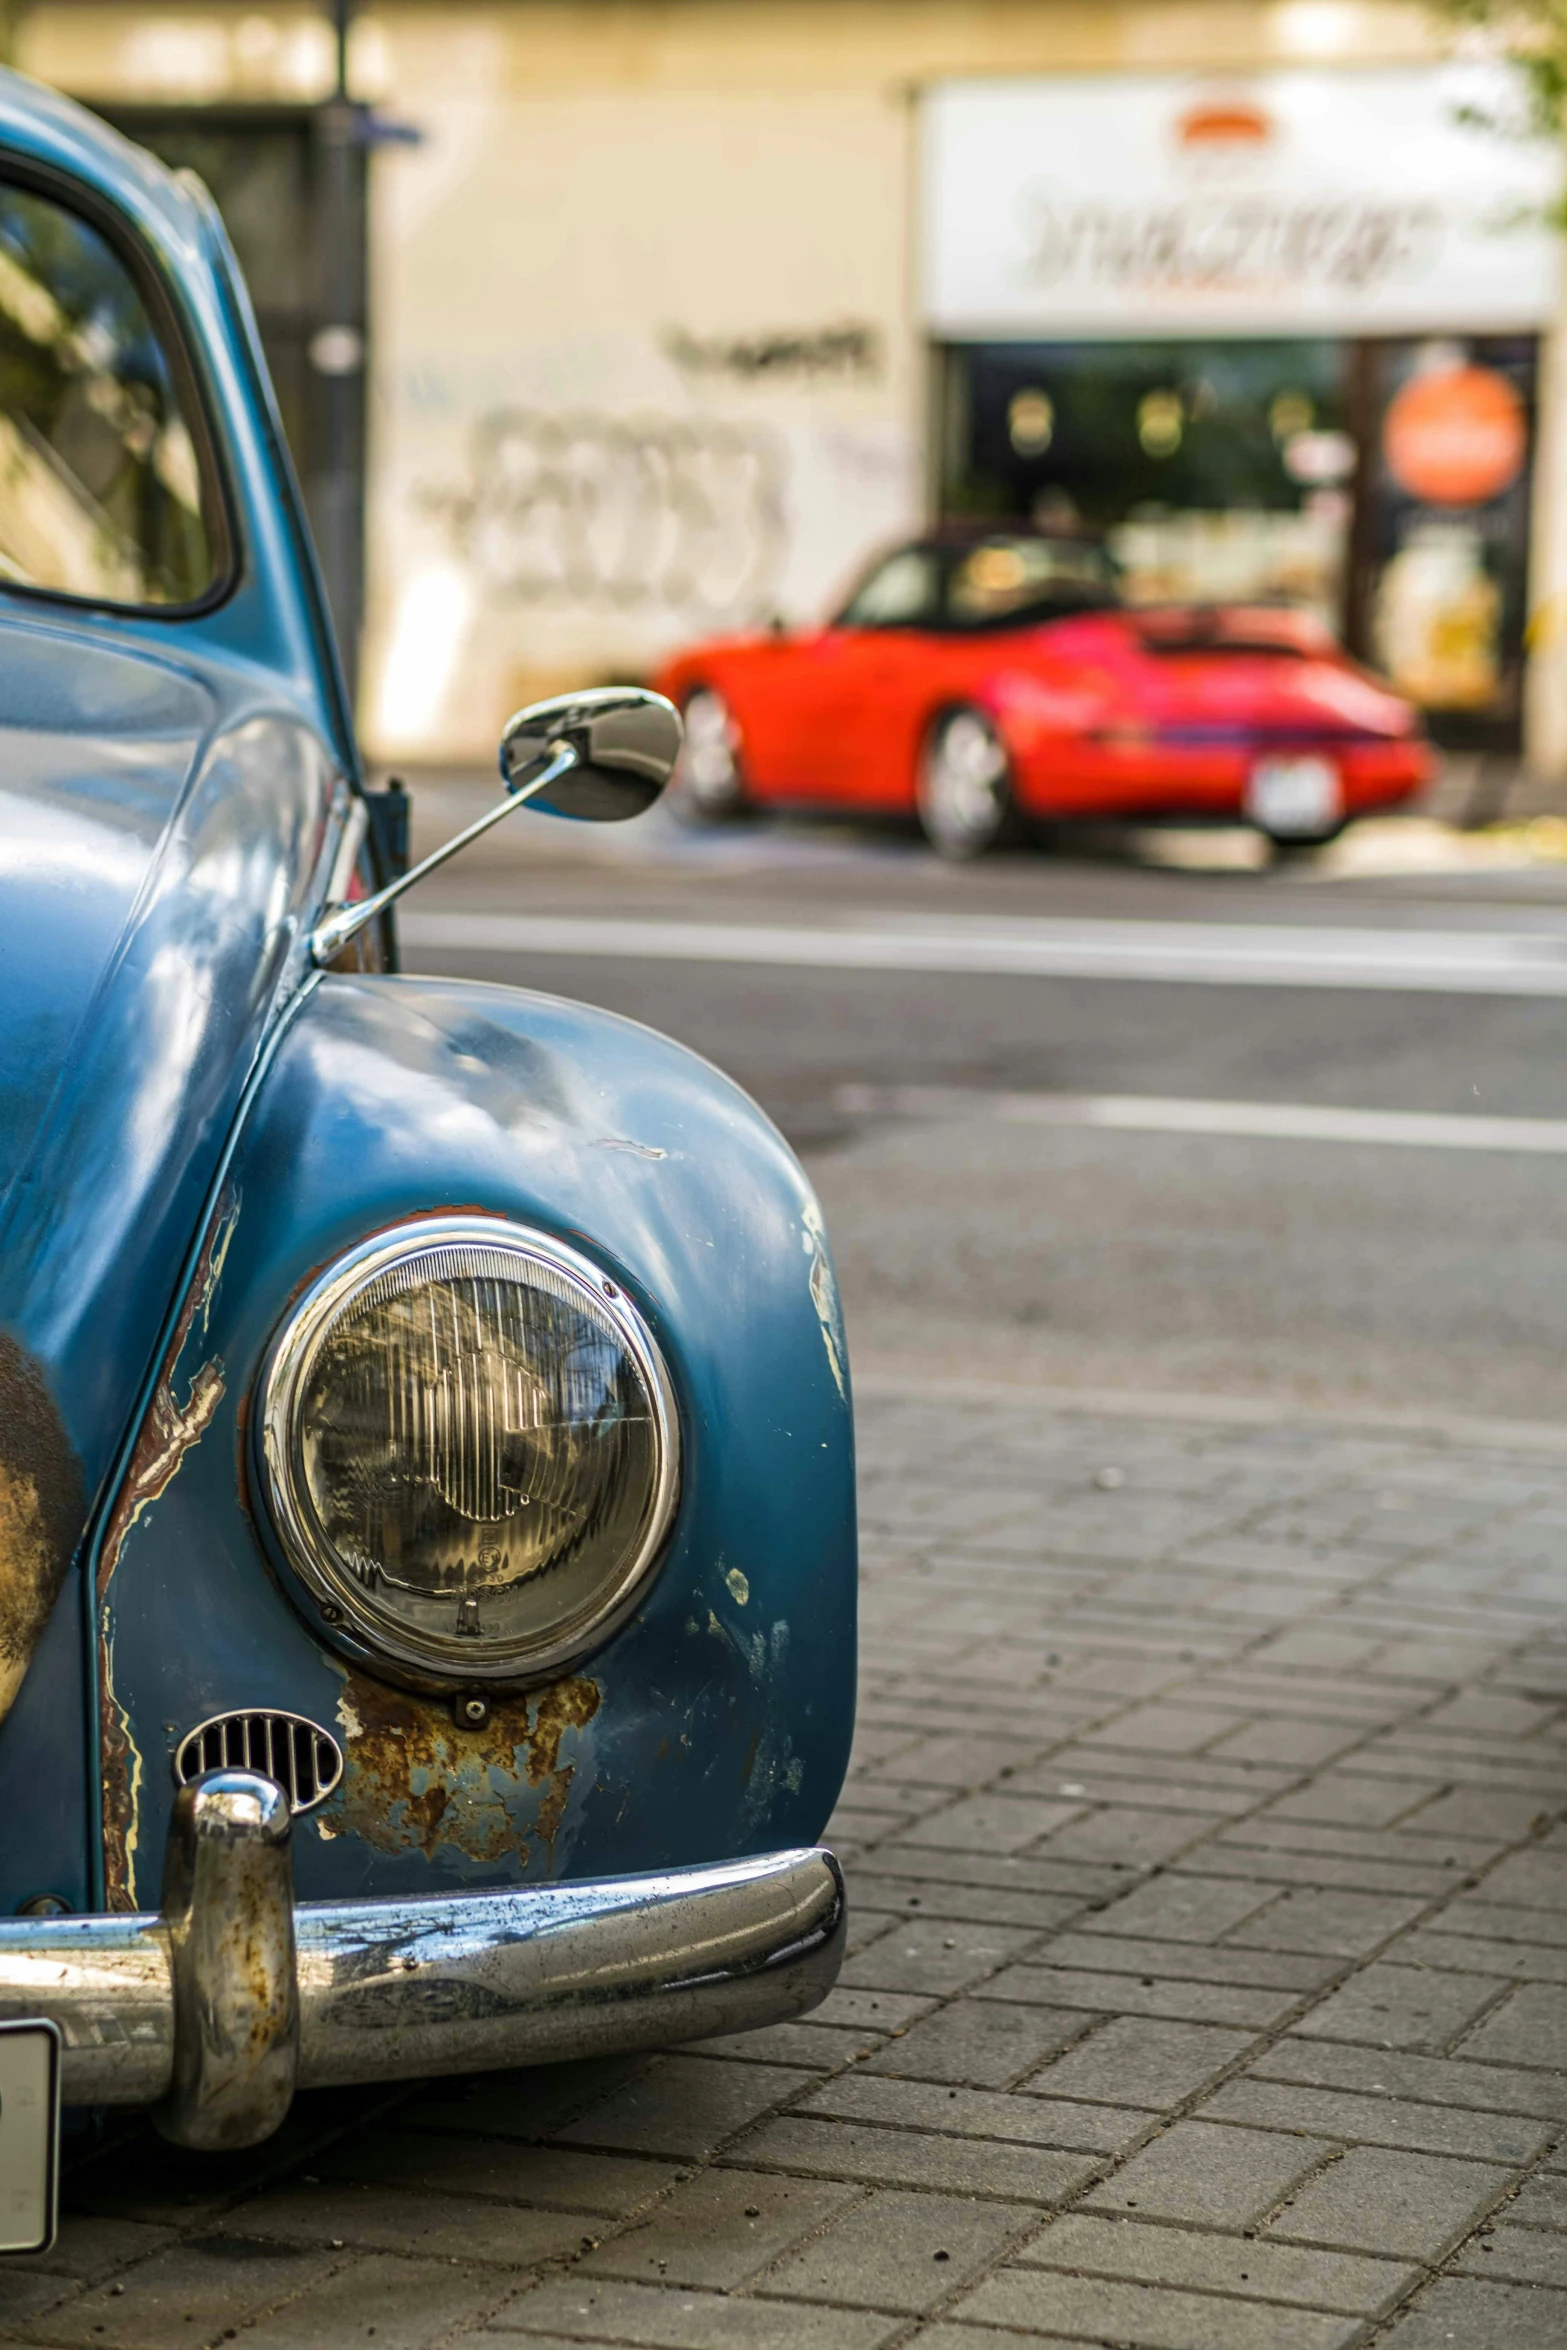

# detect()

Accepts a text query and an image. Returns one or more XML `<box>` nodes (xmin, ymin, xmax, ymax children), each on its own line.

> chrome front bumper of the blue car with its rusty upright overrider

<box><xmin>0</xmin><ymin>1770</ymin><xmax>846</xmax><ymax>2148</ymax></box>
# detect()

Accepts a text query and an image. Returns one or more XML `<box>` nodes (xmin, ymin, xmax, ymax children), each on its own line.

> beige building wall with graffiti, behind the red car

<box><xmin>19</xmin><ymin>0</ymin><xmax>1567</xmax><ymax>773</ymax></box>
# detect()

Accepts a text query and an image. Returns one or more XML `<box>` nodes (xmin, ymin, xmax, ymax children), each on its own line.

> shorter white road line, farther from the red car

<box><xmin>834</xmin><ymin>1086</ymin><xmax>1567</xmax><ymax>1156</ymax></box>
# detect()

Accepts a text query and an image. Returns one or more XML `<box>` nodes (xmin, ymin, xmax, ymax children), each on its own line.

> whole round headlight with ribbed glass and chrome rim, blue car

<box><xmin>261</xmin><ymin>1217</ymin><xmax>679</xmax><ymax>1685</ymax></box>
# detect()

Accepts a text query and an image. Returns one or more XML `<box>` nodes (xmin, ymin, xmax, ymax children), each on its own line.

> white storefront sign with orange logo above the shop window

<box><xmin>921</xmin><ymin>66</ymin><xmax>1558</xmax><ymax>341</ymax></box>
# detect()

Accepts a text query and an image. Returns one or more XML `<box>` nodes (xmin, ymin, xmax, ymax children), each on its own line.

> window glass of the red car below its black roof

<box><xmin>839</xmin><ymin>531</ymin><xmax>1121</xmax><ymax>630</ymax></box>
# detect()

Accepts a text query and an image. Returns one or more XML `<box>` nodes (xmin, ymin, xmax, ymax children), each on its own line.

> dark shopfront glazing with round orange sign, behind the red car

<box><xmin>940</xmin><ymin>336</ymin><xmax>1536</xmax><ymax>750</ymax></box>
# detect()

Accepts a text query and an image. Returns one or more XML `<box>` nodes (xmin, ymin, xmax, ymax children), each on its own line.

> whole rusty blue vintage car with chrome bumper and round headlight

<box><xmin>0</xmin><ymin>75</ymin><xmax>855</xmax><ymax>2199</ymax></box>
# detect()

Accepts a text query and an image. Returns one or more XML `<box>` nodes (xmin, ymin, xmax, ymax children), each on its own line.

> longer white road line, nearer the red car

<box><xmin>399</xmin><ymin>909</ymin><xmax>1567</xmax><ymax>996</ymax></box>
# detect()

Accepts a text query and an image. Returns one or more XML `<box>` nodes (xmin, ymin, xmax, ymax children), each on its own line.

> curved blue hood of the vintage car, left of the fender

<box><xmin>0</xmin><ymin>606</ymin><xmax>334</xmax><ymax>1716</ymax></box>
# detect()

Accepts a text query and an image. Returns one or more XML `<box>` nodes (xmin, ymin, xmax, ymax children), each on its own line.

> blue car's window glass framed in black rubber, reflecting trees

<box><xmin>0</xmin><ymin>181</ymin><xmax>221</xmax><ymax>606</ymax></box>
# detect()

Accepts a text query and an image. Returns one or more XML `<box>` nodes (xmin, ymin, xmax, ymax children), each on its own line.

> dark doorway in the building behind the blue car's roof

<box><xmin>106</xmin><ymin>106</ymin><xmax>366</xmax><ymax>691</ymax></box>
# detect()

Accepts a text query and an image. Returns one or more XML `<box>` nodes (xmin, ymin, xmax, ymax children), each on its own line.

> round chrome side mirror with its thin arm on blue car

<box><xmin>310</xmin><ymin>686</ymin><xmax>681</xmax><ymax>968</ymax></box>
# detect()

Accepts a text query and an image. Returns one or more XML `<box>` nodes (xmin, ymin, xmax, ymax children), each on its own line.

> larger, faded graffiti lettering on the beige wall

<box><xmin>423</xmin><ymin>409</ymin><xmax>787</xmax><ymax>625</ymax></box>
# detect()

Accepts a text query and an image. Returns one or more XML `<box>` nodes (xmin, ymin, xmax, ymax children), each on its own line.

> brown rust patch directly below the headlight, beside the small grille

<box><xmin>317</xmin><ymin>1673</ymin><xmax>601</xmax><ymax>1868</ymax></box>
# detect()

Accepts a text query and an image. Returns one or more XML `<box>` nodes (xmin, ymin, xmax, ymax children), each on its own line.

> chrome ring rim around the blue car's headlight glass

<box><xmin>256</xmin><ymin>1215</ymin><xmax>681</xmax><ymax>1690</ymax></box>
